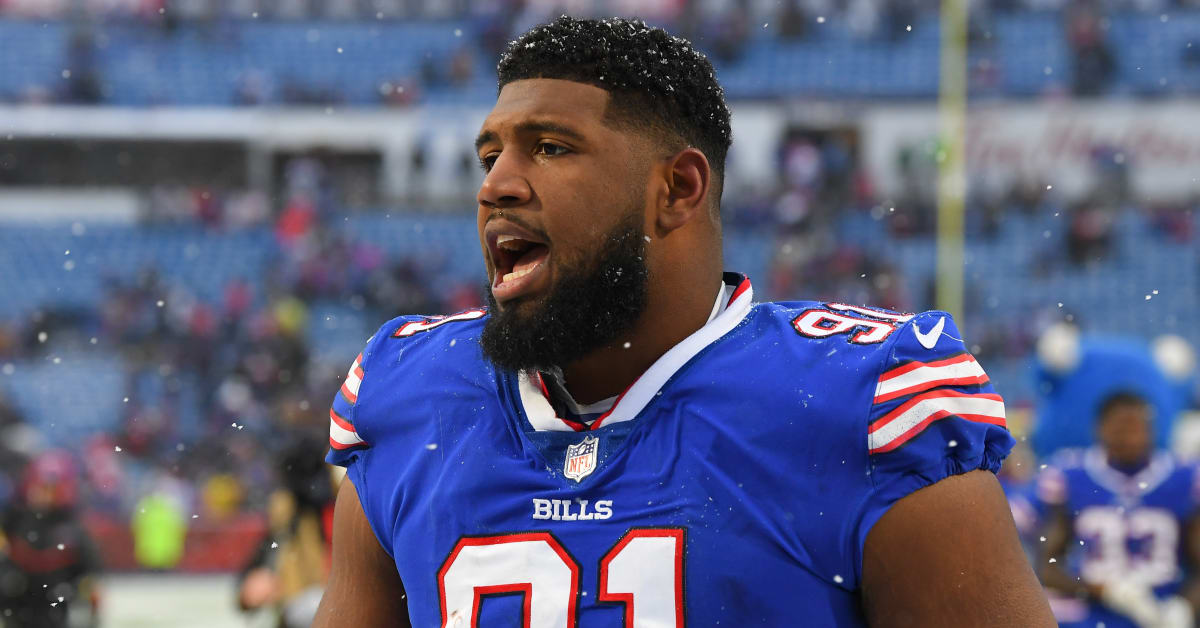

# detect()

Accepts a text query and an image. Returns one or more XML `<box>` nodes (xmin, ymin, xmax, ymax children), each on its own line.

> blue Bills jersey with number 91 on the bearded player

<box><xmin>328</xmin><ymin>274</ymin><xmax>1013</xmax><ymax>628</ymax></box>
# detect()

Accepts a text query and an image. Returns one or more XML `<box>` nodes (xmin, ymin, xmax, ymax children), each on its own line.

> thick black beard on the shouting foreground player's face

<box><xmin>479</xmin><ymin>207</ymin><xmax>649</xmax><ymax>371</ymax></box>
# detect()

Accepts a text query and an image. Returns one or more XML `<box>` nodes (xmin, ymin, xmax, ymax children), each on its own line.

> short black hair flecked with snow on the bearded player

<box><xmin>497</xmin><ymin>16</ymin><xmax>733</xmax><ymax>201</ymax></box>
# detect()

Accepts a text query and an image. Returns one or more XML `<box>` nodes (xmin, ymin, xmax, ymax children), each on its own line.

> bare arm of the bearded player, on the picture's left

<box><xmin>312</xmin><ymin>478</ymin><xmax>412</xmax><ymax>628</ymax></box>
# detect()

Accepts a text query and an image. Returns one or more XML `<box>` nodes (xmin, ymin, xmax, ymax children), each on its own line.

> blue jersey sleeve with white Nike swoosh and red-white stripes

<box><xmin>858</xmin><ymin>311</ymin><xmax>1015</xmax><ymax>561</ymax></box>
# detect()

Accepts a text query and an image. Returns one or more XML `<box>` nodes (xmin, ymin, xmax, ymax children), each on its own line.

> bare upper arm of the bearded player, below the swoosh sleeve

<box><xmin>863</xmin><ymin>471</ymin><xmax>1056</xmax><ymax>628</ymax></box>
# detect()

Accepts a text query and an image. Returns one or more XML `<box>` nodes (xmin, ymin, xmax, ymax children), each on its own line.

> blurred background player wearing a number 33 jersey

<box><xmin>1037</xmin><ymin>393</ymin><xmax>1200</xmax><ymax>628</ymax></box>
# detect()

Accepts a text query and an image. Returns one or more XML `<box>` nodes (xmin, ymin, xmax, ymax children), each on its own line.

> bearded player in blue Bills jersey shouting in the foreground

<box><xmin>314</xmin><ymin>17</ymin><xmax>1052</xmax><ymax>628</ymax></box>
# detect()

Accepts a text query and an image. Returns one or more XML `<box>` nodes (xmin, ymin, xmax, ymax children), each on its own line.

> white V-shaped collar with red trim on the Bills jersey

<box><xmin>517</xmin><ymin>273</ymin><xmax>754</xmax><ymax>432</ymax></box>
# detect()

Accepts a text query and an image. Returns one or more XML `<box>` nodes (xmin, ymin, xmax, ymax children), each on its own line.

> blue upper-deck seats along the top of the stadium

<box><xmin>0</xmin><ymin>11</ymin><xmax>1200</xmax><ymax>107</ymax></box>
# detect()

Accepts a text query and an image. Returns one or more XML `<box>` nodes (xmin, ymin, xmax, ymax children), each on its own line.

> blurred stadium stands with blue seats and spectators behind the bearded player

<box><xmin>0</xmin><ymin>0</ymin><xmax>1200</xmax><ymax>626</ymax></box>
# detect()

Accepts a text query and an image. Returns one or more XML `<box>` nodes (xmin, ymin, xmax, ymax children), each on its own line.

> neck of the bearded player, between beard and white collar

<box><xmin>563</xmin><ymin>280</ymin><xmax>720</xmax><ymax>405</ymax></box>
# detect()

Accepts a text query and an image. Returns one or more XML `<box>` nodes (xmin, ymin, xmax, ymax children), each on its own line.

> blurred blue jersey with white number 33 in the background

<box><xmin>1037</xmin><ymin>447</ymin><xmax>1200</xmax><ymax>628</ymax></box>
